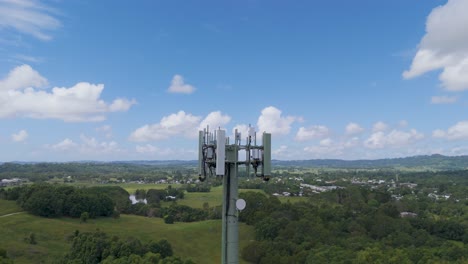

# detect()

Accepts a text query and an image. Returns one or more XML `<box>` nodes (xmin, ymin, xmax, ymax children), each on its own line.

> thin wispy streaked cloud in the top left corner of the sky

<box><xmin>0</xmin><ymin>0</ymin><xmax>61</xmax><ymax>40</ymax></box>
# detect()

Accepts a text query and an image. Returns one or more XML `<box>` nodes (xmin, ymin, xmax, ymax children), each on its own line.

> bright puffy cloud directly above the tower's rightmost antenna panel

<box><xmin>257</xmin><ymin>106</ymin><xmax>300</xmax><ymax>135</ymax></box>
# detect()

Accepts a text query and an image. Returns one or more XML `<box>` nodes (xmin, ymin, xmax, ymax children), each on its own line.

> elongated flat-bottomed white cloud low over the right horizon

<box><xmin>364</xmin><ymin>129</ymin><xmax>424</xmax><ymax>149</ymax></box>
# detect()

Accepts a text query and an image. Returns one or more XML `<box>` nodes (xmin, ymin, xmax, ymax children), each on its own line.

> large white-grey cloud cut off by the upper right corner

<box><xmin>403</xmin><ymin>0</ymin><xmax>468</xmax><ymax>91</ymax></box>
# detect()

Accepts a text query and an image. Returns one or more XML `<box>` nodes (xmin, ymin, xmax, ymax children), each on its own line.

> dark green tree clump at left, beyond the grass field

<box><xmin>0</xmin><ymin>183</ymin><xmax>130</xmax><ymax>218</ymax></box>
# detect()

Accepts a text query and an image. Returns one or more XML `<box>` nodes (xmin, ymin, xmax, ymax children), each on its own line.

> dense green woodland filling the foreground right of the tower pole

<box><xmin>240</xmin><ymin>187</ymin><xmax>468</xmax><ymax>264</ymax></box>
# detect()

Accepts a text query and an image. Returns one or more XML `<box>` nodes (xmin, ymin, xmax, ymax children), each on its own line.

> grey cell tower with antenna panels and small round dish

<box><xmin>198</xmin><ymin>126</ymin><xmax>271</xmax><ymax>264</ymax></box>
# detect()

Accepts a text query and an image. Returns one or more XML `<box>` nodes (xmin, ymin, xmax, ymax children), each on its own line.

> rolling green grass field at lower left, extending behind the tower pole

<box><xmin>0</xmin><ymin>213</ymin><xmax>253</xmax><ymax>264</ymax></box>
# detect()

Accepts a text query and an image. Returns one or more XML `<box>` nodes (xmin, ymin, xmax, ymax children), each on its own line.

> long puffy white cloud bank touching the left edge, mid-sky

<box><xmin>0</xmin><ymin>65</ymin><xmax>136</xmax><ymax>122</ymax></box>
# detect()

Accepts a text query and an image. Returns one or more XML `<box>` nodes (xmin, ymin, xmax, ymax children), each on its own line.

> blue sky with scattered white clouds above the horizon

<box><xmin>0</xmin><ymin>0</ymin><xmax>468</xmax><ymax>161</ymax></box>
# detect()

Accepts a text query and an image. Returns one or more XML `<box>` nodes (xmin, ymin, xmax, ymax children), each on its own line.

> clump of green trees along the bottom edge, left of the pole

<box><xmin>61</xmin><ymin>230</ymin><xmax>195</xmax><ymax>264</ymax></box>
